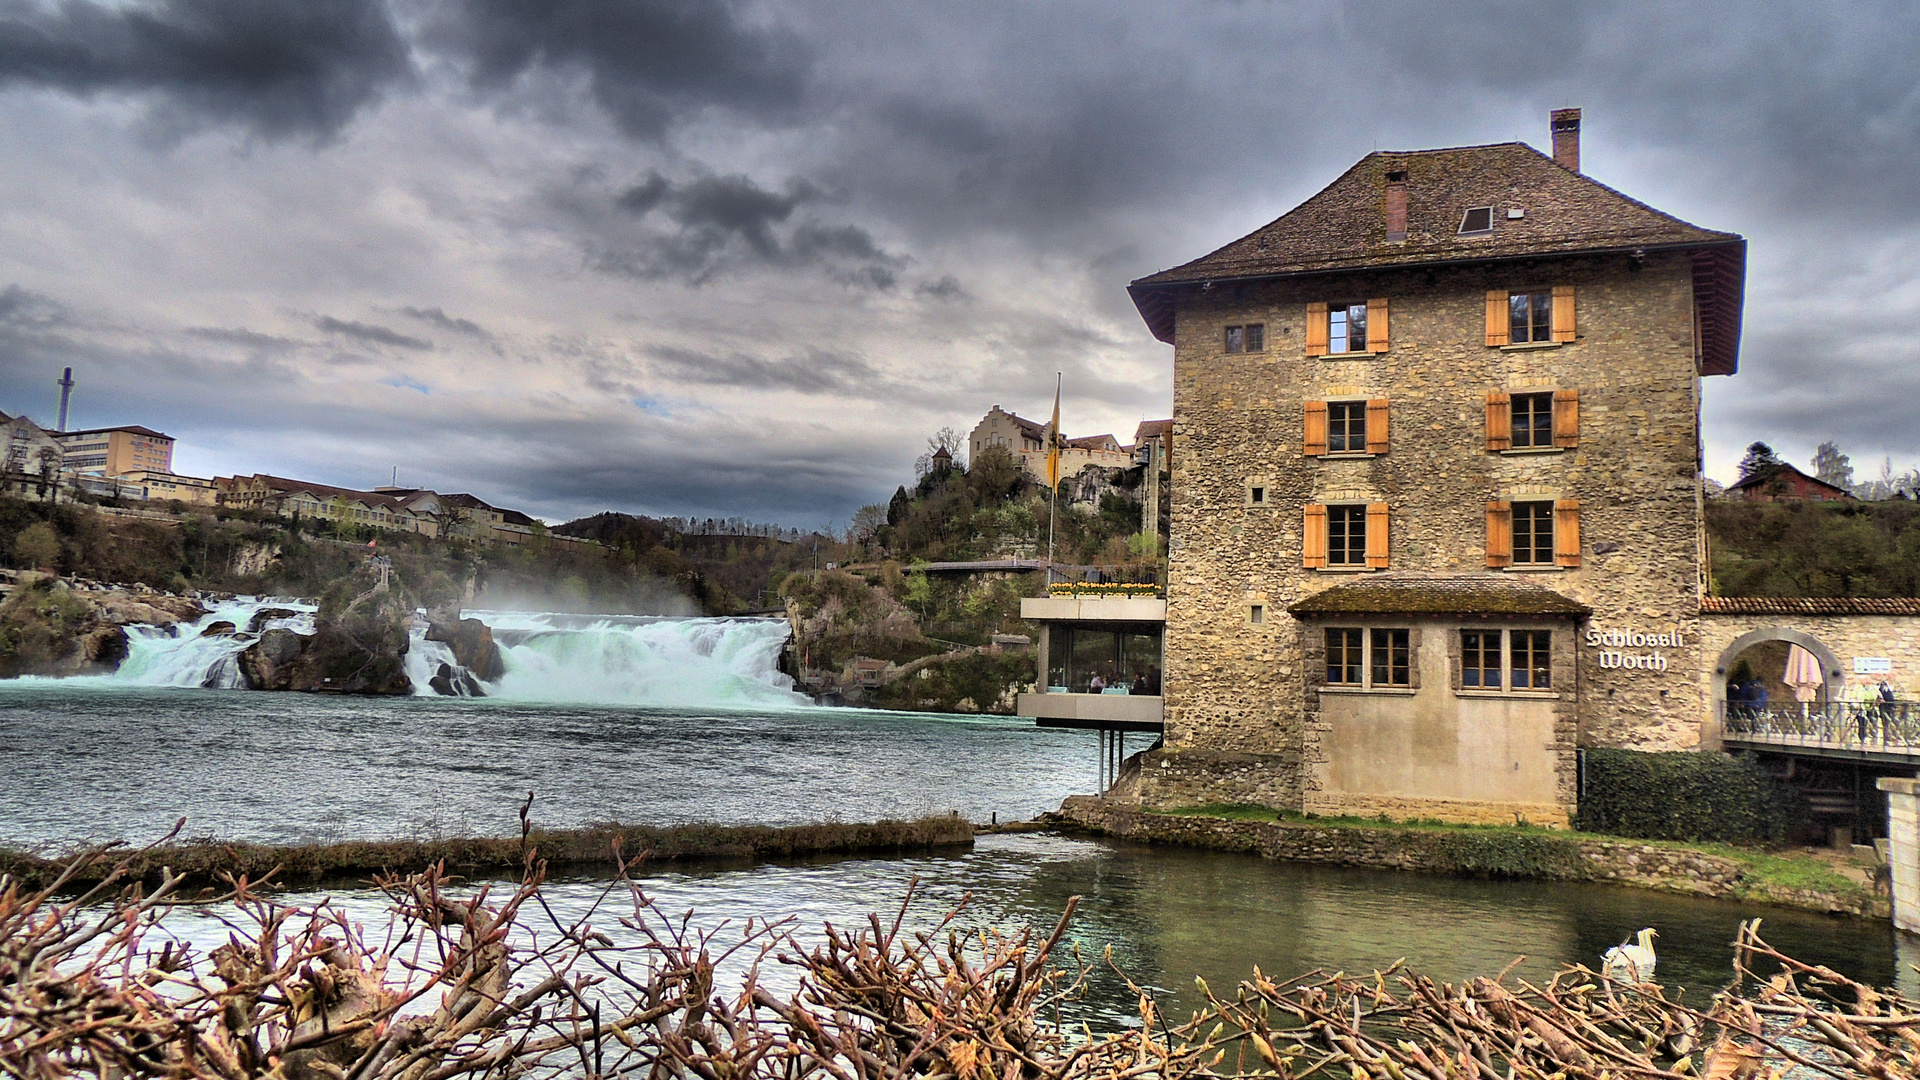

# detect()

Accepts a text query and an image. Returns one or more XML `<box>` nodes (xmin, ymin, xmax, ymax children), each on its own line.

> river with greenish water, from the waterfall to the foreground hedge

<box><xmin>0</xmin><ymin>599</ymin><xmax>1920</xmax><ymax>1022</ymax></box>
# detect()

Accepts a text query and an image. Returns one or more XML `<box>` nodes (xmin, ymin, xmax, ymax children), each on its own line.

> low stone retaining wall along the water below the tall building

<box><xmin>1056</xmin><ymin>796</ymin><xmax>1891</xmax><ymax>919</ymax></box>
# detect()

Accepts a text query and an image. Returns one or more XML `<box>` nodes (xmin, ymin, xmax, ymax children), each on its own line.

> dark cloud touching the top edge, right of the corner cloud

<box><xmin>430</xmin><ymin>0</ymin><xmax>810</xmax><ymax>138</ymax></box>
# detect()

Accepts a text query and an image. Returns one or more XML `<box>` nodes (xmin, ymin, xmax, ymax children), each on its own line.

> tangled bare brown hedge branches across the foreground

<box><xmin>0</xmin><ymin>826</ymin><xmax>1920</xmax><ymax>1080</ymax></box>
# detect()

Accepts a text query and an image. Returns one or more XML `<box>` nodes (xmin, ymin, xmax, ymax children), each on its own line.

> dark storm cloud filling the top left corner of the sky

<box><xmin>0</xmin><ymin>0</ymin><xmax>413</xmax><ymax>138</ymax></box>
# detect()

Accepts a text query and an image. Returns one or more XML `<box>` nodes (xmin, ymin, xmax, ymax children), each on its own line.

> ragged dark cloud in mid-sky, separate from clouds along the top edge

<box><xmin>597</xmin><ymin>173</ymin><xmax>906</xmax><ymax>290</ymax></box>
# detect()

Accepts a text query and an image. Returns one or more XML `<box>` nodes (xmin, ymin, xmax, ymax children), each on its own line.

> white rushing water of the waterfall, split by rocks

<box><xmin>86</xmin><ymin>598</ymin><xmax>808</xmax><ymax>707</ymax></box>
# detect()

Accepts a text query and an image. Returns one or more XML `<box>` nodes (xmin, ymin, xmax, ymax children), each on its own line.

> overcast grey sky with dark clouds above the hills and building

<box><xmin>0</xmin><ymin>0</ymin><xmax>1920</xmax><ymax>527</ymax></box>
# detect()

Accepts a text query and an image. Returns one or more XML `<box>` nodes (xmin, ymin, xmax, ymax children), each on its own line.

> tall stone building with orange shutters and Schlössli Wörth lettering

<box><xmin>1129</xmin><ymin>110</ymin><xmax>1745</xmax><ymax>824</ymax></box>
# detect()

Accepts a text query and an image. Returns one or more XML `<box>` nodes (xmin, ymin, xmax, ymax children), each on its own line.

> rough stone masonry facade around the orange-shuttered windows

<box><xmin>1142</xmin><ymin>254</ymin><xmax>1703</xmax><ymax>809</ymax></box>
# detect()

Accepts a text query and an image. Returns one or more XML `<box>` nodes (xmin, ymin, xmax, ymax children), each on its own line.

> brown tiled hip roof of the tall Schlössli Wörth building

<box><xmin>1127</xmin><ymin>142</ymin><xmax>1745</xmax><ymax>375</ymax></box>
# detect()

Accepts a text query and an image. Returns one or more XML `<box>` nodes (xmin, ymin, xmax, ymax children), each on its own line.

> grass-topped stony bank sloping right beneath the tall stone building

<box><xmin>1052</xmin><ymin>796</ymin><xmax>1891</xmax><ymax>919</ymax></box>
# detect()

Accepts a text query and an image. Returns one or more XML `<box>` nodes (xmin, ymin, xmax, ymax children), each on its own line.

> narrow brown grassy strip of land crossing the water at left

<box><xmin>0</xmin><ymin>815</ymin><xmax>973</xmax><ymax>888</ymax></box>
